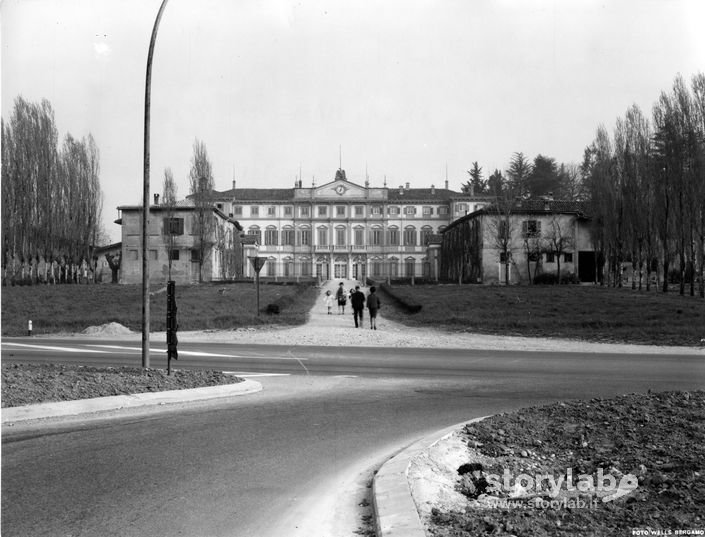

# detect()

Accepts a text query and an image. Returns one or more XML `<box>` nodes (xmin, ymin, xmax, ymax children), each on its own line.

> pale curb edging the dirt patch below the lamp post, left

<box><xmin>0</xmin><ymin>379</ymin><xmax>262</xmax><ymax>425</ymax></box>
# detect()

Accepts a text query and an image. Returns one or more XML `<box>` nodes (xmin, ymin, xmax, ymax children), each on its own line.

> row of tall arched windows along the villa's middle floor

<box><xmin>247</xmin><ymin>226</ymin><xmax>442</xmax><ymax>246</ymax></box>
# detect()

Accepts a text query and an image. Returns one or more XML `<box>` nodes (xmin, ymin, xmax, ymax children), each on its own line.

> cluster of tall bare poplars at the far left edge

<box><xmin>2</xmin><ymin>96</ymin><xmax>103</xmax><ymax>268</ymax></box>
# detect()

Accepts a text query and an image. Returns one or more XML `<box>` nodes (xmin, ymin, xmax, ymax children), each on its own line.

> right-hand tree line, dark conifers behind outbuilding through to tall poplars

<box><xmin>462</xmin><ymin>73</ymin><xmax>705</xmax><ymax>297</ymax></box>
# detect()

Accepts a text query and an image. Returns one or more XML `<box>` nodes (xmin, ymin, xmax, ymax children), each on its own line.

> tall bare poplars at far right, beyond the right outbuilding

<box><xmin>581</xmin><ymin>73</ymin><xmax>705</xmax><ymax>297</ymax></box>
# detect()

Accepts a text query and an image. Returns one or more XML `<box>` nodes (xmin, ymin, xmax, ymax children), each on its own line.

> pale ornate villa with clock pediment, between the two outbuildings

<box><xmin>213</xmin><ymin>170</ymin><xmax>489</xmax><ymax>280</ymax></box>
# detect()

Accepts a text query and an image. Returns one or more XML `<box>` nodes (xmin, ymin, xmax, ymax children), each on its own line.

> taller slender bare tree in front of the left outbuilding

<box><xmin>189</xmin><ymin>139</ymin><xmax>215</xmax><ymax>282</ymax></box>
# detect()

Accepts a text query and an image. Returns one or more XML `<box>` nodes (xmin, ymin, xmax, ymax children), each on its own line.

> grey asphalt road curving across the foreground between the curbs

<box><xmin>2</xmin><ymin>338</ymin><xmax>705</xmax><ymax>536</ymax></box>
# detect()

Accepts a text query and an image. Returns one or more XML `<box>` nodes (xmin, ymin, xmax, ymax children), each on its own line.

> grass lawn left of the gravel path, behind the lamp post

<box><xmin>2</xmin><ymin>283</ymin><xmax>318</xmax><ymax>336</ymax></box>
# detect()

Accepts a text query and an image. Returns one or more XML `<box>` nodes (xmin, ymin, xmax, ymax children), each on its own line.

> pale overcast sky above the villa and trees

<box><xmin>1</xmin><ymin>0</ymin><xmax>705</xmax><ymax>241</ymax></box>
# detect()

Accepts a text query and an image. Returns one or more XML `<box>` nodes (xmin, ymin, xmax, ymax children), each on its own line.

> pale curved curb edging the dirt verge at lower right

<box><xmin>372</xmin><ymin>416</ymin><xmax>488</xmax><ymax>537</ymax></box>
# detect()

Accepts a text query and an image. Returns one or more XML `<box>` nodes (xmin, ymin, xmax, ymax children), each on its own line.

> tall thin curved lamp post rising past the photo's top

<box><xmin>142</xmin><ymin>0</ymin><xmax>169</xmax><ymax>369</ymax></box>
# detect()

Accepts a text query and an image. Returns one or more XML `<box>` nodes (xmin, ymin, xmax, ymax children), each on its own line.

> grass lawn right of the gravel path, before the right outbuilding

<box><xmin>382</xmin><ymin>284</ymin><xmax>705</xmax><ymax>346</ymax></box>
